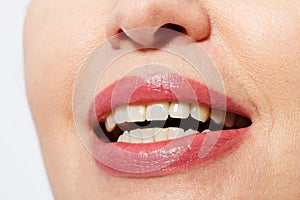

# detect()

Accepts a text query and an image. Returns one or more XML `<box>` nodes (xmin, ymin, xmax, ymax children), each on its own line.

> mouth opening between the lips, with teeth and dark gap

<box><xmin>95</xmin><ymin>102</ymin><xmax>251</xmax><ymax>144</ymax></box>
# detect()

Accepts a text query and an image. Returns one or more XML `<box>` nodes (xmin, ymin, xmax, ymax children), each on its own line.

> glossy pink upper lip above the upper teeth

<box><xmin>90</xmin><ymin>74</ymin><xmax>250</xmax><ymax>121</ymax></box>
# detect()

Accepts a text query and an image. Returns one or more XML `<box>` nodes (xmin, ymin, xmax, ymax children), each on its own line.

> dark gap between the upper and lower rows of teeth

<box><xmin>94</xmin><ymin>113</ymin><xmax>252</xmax><ymax>143</ymax></box>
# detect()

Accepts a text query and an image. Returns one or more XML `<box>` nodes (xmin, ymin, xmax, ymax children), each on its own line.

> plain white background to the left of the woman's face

<box><xmin>0</xmin><ymin>0</ymin><xmax>53</xmax><ymax>200</ymax></box>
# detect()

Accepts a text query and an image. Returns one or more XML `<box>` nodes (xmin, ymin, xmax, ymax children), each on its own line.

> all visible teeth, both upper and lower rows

<box><xmin>109</xmin><ymin>102</ymin><xmax>251</xmax><ymax>144</ymax></box>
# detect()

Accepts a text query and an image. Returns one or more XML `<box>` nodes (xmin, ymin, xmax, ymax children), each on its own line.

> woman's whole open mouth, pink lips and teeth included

<box><xmin>90</xmin><ymin>74</ymin><xmax>252</xmax><ymax>177</ymax></box>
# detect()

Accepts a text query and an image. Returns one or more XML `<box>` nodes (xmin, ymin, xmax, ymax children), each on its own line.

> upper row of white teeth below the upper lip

<box><xmin>105</xmin><ymin>102</ymin><xmax>238</xmax><ymax>132</ymax></box>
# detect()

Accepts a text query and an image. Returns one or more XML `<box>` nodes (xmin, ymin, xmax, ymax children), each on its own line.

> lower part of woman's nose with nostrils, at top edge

<box><xmin>106</xmin><ymin>0</ymin><xmax>210</xmax><ymax>46</ymax></box>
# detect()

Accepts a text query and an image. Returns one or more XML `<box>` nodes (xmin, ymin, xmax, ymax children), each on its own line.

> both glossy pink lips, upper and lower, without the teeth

<box><xmin>90</xmin><ymin>74</ymin><xmax>250</xmax><ymax>177</ymax></box>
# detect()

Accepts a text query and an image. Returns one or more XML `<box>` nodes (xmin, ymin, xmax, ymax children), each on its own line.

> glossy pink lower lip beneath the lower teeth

<box><xmin>91</xmin><ymin>127</ymin><xmax>250</xmax><ymax>177</ymax></box>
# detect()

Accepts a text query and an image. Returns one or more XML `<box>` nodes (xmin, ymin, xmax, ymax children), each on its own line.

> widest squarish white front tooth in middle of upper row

<box><xmin>146</xmin><ymin>103</ymin><xmax>169</xmax><ymax>121</ymax></box>
